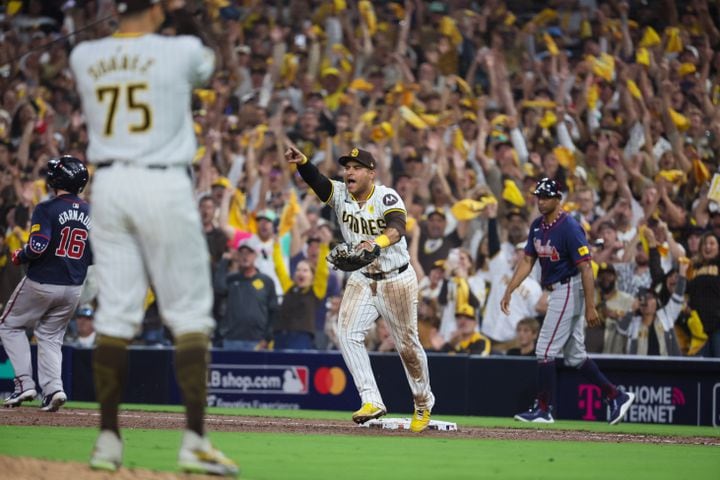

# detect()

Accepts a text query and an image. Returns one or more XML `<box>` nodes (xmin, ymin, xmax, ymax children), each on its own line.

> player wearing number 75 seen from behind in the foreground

<box><xmin>70</xmin><ymin>0</ymin><xmax>238</xmax><ymax>476</ymax></box>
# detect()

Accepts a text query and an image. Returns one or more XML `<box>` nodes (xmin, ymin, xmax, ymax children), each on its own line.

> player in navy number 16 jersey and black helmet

<box><xmin>0</xmin><ymin>156</ymin><xmax>92</xmax><ymax>412</ymax></box>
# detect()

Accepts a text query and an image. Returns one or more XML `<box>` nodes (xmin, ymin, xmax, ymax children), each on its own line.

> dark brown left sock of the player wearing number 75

<box><xmin>93</xmin><ymin>335</ymin><xmax>130</xmax><ymax>436</ymax></box>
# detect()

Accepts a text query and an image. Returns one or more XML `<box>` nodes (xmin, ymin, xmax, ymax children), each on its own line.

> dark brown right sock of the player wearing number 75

<box><xmin>175</xmin><ymin>333</ymin><xmax>209</xmax><ymax>437</ymax></box>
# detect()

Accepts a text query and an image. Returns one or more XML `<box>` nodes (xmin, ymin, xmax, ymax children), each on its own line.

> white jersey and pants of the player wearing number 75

<box><xmin>70</xmin><ymin>34</ymin><xmax>215</xmax><ymax>339</ymax></box>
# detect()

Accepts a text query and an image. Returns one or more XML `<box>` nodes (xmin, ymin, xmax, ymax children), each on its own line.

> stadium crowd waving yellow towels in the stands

<box><xmin>0</xmin><ymin>0</ymin><xmax>720</xmax><ymax>357</ymax></box>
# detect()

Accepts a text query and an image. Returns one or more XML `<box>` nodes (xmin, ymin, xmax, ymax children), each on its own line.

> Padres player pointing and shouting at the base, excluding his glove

<box><xmin>285</xmin><ymin>147</ymin><xmax>435</xmax><ymax>432</ymax></box>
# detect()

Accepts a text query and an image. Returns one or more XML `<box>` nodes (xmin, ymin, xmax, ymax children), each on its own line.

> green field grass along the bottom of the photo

<box><xmin>0</xmin><ymin>402</ymin><xmax>720</xmax><ymax>480</ymax></box>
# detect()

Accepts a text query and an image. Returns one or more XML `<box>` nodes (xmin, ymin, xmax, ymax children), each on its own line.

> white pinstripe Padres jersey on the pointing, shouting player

<box><xmin>328</xmin><ymin>180</ymin><xmax>410</xmax><ymax>273</ymax></box>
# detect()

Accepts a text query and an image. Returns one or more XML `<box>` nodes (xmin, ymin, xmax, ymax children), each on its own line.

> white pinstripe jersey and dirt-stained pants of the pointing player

<box><xmin>328</xmin><ymin>181</ymin><xmax>435</xmax><ymax>410</ymax></box>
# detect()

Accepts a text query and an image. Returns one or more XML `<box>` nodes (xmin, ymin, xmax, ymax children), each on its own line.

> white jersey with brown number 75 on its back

<box><xmin>70</xmin><ymin>34</ymin><xmax>215</xmax><ymax>166</ymax></box>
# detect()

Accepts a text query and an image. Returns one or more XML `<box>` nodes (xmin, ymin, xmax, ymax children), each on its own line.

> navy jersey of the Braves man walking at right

<box><xmin>525</xmin><ymin>211</ymin><xmax>590</xmax><ymax>287</ymax></box>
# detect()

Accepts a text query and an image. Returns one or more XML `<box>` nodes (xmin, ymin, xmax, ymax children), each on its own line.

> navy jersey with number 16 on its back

<box><xmin>21</xmin><ymin>194</ymin><xmax>92</xmax><ymax>285</ymax></box>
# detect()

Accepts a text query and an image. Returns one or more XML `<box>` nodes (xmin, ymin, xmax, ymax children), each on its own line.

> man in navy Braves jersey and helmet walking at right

<box><xmin>500</xmin><ymin>178</ymin><xmax>635</xmax><ymax>425</ymax></box>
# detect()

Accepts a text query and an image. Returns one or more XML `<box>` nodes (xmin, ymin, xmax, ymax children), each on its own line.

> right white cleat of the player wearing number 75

<box><xmin>178</xmin><ymin>430</ymin><xmax>240</xmax><ymax>477</ymax></box>
